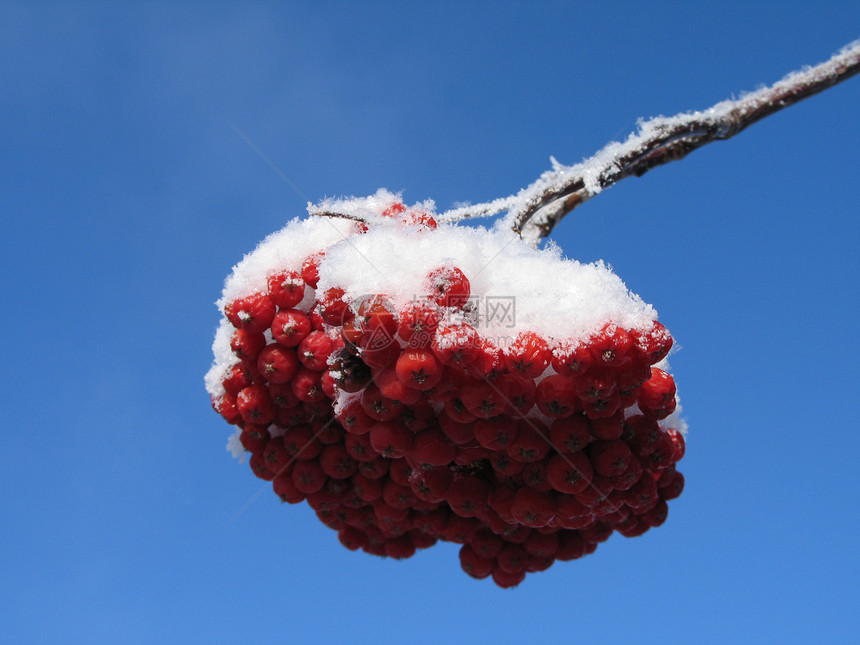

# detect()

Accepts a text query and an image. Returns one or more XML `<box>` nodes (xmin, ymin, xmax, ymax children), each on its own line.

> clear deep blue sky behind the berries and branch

<box><xmin>0</xmin><ymin>1</ymin><xmax>860</xmax><ymax>643</ymax></box>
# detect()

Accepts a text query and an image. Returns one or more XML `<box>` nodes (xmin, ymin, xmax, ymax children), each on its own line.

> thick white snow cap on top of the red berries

<box><xmin>206</xmin><ymin>190</ymin><xmax>657</xmax><ymax>398</ymax></box>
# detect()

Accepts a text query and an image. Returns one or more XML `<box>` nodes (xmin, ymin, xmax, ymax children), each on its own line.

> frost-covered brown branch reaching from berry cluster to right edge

<box><xmin>439</xmin><ymin>40</ymin><xmax>860</xmax><ymax>243</ymax></box>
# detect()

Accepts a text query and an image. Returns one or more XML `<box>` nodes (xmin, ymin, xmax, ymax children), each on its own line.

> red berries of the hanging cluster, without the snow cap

<box><xmin>213</xmin><ymin>204</ymin><xmax>684</xmax><ymax>587</ymax></box>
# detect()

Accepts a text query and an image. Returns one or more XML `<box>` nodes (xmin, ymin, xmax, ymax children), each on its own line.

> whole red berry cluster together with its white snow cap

<box><xmin>206</xmin><ymin>190</ymin><xmax>685</xmax><ymax>587</ymax></box>
